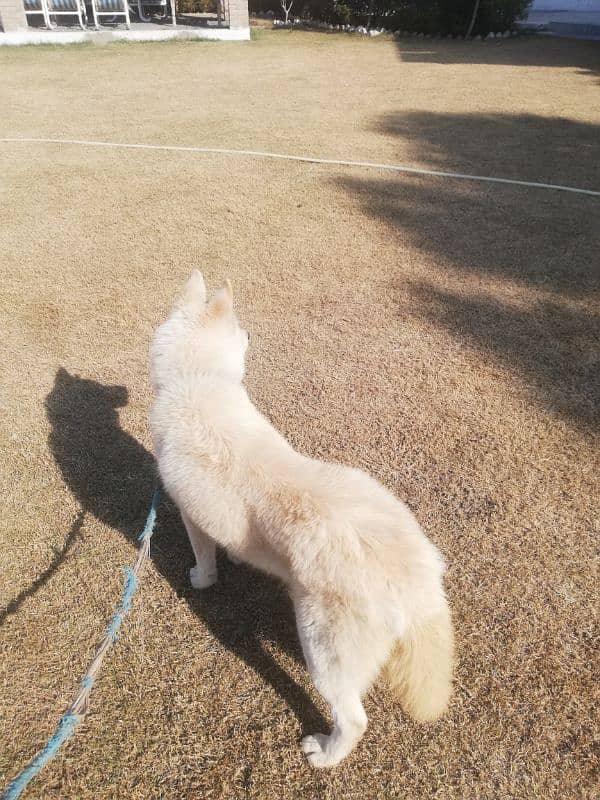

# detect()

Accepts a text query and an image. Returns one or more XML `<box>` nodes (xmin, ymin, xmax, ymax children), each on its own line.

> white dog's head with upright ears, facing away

<box><xmin>150</xmin><ymin>270</ymin><xmax>249</xmax><ymax>388</ymax></box>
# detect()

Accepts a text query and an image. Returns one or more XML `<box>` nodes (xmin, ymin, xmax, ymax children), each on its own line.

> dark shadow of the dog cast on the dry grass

<box><xmin>41</xmin><ymin>368</ymin><xmax>327</xmax><ymax>732</ymax></box>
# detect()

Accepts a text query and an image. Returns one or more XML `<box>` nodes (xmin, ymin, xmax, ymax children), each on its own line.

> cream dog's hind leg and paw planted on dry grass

<box><xmin>295</xmin><ymin>596</ymin><xmax>389</xmax><ymax>767</ymax></box>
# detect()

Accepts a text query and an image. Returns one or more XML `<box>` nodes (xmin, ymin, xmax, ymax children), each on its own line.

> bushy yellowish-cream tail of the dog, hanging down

<box><xmin>385</xmin><ymin>604</ymin><xmax>454</xmax><ymax>722</ymax></box>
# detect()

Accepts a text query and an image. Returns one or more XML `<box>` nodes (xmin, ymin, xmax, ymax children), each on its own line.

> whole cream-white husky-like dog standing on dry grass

<box><xmin>151</xmin><ymin>271</ymin><xmax>453</xmax><ymax>767</ymax></box>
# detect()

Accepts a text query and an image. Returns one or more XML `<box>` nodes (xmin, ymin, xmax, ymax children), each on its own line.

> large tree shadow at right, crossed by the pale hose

<box><xmin>336</xmin><ymin>113</ymin><xmax>600</xmax><ymax>430</ymax></box>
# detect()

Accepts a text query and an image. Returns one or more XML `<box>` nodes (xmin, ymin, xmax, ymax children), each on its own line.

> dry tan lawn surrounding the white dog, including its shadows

<box><xmin>0</xmin><ymin>28</ymin><xmax>600</xmax><ymax>800</ymax></box>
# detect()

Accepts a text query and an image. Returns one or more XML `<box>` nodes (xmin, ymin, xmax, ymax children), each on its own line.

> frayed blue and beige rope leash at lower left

<box><xmin>0</xmin><ymin>489</ymin><xmax>160</xmax><ymax>800</ymax></box>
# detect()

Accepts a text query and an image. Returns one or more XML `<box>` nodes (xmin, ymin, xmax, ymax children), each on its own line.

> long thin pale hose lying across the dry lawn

<box><xmin>0</xmin><ymin>138</ymin><xmax>600</xmax><ymax>197</ymax></box>
